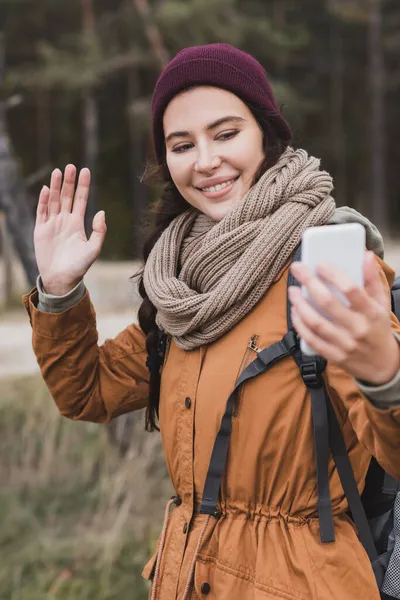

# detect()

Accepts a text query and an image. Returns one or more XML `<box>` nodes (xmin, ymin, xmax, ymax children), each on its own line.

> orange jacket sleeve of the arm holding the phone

<box><xmin>326</xmin><ymin>259</ymin><xmax>400</xmax><ymax>480</ymax></box>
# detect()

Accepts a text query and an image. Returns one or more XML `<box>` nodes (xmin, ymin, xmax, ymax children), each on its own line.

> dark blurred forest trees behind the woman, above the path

<box><xmin>0</xmin><ymin>0</ymin><xmax>400</xmax><ymax>259</ymax></box>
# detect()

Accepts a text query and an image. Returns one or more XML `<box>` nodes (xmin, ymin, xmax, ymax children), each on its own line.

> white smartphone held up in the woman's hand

<box><xmin>300</xmin><ymin>223</ymin><xmax>365</xmax><ymax>356</ymax></box>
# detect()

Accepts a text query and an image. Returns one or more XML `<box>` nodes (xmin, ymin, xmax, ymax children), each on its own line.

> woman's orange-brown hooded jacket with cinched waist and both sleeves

<box><xmin>24</xmin><ymin>263</ymin><xmax>400</xmax><ymax>600</ymax></box>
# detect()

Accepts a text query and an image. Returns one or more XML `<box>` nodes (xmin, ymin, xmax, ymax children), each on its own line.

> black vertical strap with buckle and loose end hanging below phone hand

<box><xmin>287</xmin><ymin>246</ymin><xmax>335</xmax><ymax>543</ymax></box>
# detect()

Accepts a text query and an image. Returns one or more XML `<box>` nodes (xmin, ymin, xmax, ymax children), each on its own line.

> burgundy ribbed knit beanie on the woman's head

<box><xmin>152</xmin><ymin>44</ymin><xmax>291</xmax><ymax>164</ymax></box>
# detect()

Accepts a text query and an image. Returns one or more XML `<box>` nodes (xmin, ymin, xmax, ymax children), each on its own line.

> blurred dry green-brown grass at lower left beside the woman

<box><xmin>0</xmin><ymin>376</ymin><xmax>171</xmax><ymax>600</ymax></box>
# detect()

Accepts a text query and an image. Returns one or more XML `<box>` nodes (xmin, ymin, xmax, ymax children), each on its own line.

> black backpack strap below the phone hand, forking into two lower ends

<box><xmin>287</xmin><ymin>246</ymin><xmax>378</xmax><ymax>562</ymax></box>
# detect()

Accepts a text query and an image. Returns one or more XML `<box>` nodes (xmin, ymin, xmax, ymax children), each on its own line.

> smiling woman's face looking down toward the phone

<box><xmin>163</xmin><ymin>86</ymin><xmax>264</xmax><ymax>221</ymax></box>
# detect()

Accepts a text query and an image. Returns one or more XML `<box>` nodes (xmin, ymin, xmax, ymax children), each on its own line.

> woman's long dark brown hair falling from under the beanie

<box><xmin>135</xmin><ymin>104</ymin><xmax>290</xmax><ymax>431</ymax></box>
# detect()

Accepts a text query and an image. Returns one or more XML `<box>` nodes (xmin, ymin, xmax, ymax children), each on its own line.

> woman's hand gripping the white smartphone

<box><xmin>289</xmin><ymin>252</ymin><xmax>400</xmax><ymax>385</ymax></box>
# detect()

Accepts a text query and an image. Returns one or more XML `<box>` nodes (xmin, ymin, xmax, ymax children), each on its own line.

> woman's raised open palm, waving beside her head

<box><xmin>34</xmin><ymin>165</ymin><xmax>107</xmax><ymax>296</ymax></box>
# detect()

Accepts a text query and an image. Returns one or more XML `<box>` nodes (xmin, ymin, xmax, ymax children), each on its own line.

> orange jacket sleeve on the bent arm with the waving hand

<box><xmin>23</xmin><ymin>288</ymin><xmax>148</xmax><ymax>423</ymax></box>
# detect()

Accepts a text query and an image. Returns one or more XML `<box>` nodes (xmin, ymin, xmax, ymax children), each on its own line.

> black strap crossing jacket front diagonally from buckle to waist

<box><xmin>199</xmin><ymin>331</ymin><xmax>297</xmax><ymax>516</ymax></box>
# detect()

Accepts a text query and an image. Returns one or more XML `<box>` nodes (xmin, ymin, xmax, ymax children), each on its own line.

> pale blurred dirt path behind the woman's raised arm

<box><xmin>0</xmin><ymin>242</ymin><xmax>400</xmax><ymax>378</ymax></box>
